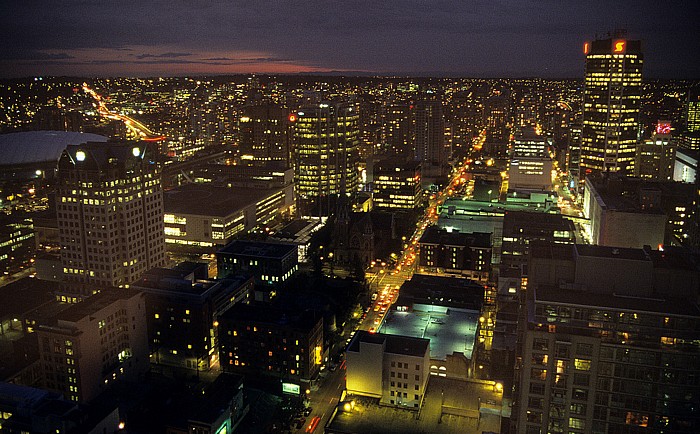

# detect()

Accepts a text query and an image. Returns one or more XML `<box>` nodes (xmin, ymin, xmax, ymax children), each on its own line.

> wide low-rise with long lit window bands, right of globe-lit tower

<box><xmin>164</xmin><ymin>184</ymin><xmax>294</xmax><ymax>252</ymax></box>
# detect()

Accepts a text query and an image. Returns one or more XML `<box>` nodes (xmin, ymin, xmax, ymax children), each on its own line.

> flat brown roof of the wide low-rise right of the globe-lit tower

<box><xmin>163</xmin><ymin>184</ymin><xmax>282</xmax><ymax>217</ymax></box>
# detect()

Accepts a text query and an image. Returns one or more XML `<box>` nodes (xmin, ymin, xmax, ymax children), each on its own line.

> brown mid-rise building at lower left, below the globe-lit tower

<box><xmin>36</xmin><ymin>288</ymin><xmax>148</xmax><ymax>402</ymax></box>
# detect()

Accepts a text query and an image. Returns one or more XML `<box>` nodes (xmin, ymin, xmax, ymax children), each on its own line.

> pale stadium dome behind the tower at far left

<box><xmin>0</xmin><ymin>131</ymin><xmax>107</xmax><ymax>167</ymax></box>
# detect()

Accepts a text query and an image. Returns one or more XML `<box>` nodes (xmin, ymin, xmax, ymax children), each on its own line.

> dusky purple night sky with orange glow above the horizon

<box><xmin>0</xmin><ymin>0</ymin><xmax>700</xmax><ymax>78</ymax></box>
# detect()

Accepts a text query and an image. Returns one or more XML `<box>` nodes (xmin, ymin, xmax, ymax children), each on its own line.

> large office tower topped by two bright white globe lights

<box><xmin>56</xmin><ymin>142</ymin><xmax>165</xmax><ymax>287</ymax></box>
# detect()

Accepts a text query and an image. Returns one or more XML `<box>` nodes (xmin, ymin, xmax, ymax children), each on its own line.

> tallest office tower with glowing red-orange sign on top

<box><xmin>581</xmin><ymin>37</ymin><xmax>643</xmax><ymax>176</ymax></box>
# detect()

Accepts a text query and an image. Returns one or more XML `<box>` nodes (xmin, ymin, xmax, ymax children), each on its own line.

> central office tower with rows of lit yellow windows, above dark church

<box><xmin>294</xmin><ymin>103</ymin><xmax>360</xmax><ymax>215</ymax></box>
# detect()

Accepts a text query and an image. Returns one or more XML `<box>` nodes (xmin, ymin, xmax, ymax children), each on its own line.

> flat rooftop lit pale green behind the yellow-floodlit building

<box><xmin>379</xmin><ymin>305</ymin><xmax>479</xmax><ymax>360</ymax></box>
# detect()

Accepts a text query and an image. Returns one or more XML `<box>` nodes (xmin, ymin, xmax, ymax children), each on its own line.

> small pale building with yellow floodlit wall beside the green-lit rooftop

<box><xmin>345</xmin><ymin>331</ymin><xmax>430</xmax><ymax>410</ymax></box>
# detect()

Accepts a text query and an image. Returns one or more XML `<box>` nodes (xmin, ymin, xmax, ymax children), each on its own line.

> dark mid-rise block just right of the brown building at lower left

<box><xmin>132</xmin><ymin>264</ymin><xmax>253</xmax><ymax>371</ymax></box>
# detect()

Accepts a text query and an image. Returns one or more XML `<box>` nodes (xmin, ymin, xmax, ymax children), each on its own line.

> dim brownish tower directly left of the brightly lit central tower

<box><xmin>239</xmin><ymin>103</ymin><xmax>294</xmax><ymax>167</ymax></box>
